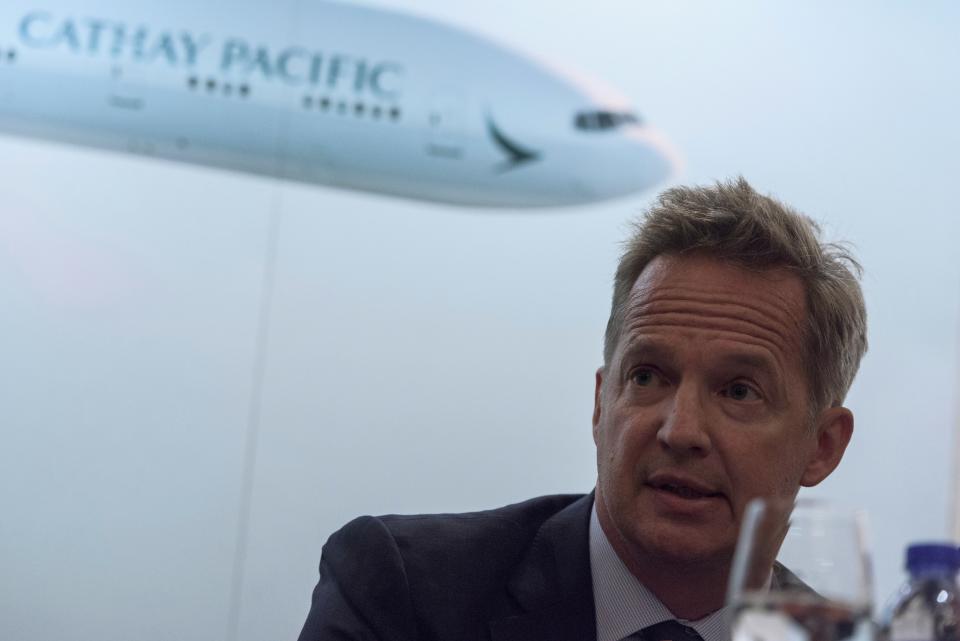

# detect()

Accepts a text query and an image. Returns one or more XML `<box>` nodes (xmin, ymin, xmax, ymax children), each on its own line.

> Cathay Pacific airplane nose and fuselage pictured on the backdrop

<box><xmin>0</xmin><ymin>0</ymin><xmax>676</xmax><ymax>207</ymax></box>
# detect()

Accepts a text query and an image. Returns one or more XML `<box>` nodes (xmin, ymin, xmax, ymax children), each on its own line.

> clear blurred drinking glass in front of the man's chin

<box><xmin>727</xmin><ymin>499</ymin><xmax>874</xmax><ymax>641</ymax></box>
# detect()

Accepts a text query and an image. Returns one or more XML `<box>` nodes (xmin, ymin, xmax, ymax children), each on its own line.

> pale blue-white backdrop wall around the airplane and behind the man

<box><xmin>0</xmin><ymin>0</ymin><xmax>960</xmax><ymax>641</ymax></box>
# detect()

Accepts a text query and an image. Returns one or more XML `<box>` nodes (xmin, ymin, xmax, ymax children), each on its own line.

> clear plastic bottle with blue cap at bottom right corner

<box><xmin>880</xmin><ymin>543</ymin><xmax>960</xmax><ymax>641</ymax></box>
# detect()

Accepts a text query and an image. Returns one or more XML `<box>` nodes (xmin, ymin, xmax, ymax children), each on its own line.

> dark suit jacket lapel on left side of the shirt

<box><xmin>490</xmin><ymin>494</ymin><xmax>597</xmax><ymax>641</ymax></box>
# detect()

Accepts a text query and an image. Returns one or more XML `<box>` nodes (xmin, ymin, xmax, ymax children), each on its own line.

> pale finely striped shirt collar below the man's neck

<box><xmin>590</xmin><ymin>501</ymin><xmax>729</xmax><ymax>641</ymax></box>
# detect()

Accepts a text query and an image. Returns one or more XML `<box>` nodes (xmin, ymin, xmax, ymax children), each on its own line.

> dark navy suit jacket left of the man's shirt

<box><xmin>300</xmin><ymin>495</ymin><xmax>596</xmax><ymax>641</ymax></box>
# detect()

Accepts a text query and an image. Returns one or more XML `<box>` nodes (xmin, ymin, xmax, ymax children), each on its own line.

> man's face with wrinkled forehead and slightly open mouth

<box><xmin>593</xmin><ymin>256</ymin><xmax>840</xmax><ymax>563</ymax></box>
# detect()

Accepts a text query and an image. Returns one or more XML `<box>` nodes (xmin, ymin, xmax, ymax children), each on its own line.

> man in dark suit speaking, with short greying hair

<box><xmin>300</xmin><ymin>179</ymin><xmax>866</xmax><ymax>641</ymax></box>
